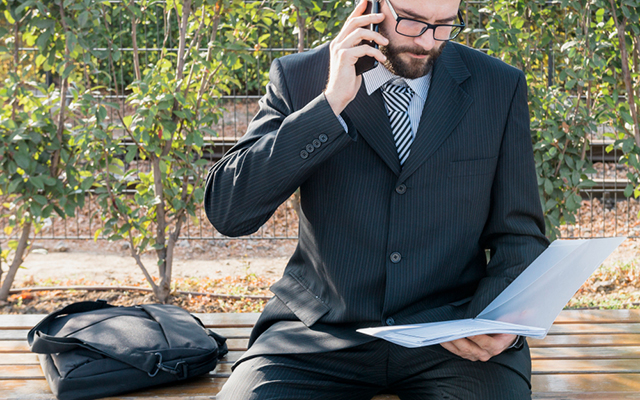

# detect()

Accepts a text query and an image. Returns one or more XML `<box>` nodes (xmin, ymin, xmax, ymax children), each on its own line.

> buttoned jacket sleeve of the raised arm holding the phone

<box><xmin>204</xmin><ymin>59</ymin><xmax>356</xmax><ymax>236</ymax></box>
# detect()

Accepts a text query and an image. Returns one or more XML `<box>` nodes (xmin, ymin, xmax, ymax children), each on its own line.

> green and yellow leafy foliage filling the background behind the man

<box><xmin>0</xmin><ymin>0</ymin><xmax>640</xmax><ymax>299</ymax></box>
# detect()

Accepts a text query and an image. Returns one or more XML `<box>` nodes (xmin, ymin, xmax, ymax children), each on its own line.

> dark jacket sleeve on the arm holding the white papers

<box><xmin>466</xmin><ymin>72</ymin><xmax>549</xmax><ymax>318</ymax></box>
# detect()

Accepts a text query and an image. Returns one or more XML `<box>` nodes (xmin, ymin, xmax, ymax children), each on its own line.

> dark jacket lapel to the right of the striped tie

<box><xmin>400</xmin><ymin>43</ymin><xmax>473</xmax><ymax>181</ymax></box>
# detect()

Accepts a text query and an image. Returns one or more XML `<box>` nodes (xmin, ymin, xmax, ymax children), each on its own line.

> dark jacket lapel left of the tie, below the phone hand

<box><xmin>345</xmin><ymin>81</ymin><xmax>400</xmax><ymax>175</ymax></box>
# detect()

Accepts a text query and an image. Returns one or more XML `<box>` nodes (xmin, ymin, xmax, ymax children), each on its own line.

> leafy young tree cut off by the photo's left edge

<box><xmin>0</xmin><ymin>1</ymin><xmax>91</xmax><ymax>301</ymax></box>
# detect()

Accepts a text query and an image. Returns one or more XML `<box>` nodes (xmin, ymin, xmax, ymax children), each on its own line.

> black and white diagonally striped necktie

<box><xmin>382</xmin><ymin>84</ymin><xmax>414</xmax><ymax>166</ymax></box>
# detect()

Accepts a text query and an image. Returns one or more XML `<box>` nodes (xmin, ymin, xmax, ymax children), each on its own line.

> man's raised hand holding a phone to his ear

<box><xmin>325</xmin><ymin>0</ymin><xmax>389</xmax><ymax>115</ymax></box>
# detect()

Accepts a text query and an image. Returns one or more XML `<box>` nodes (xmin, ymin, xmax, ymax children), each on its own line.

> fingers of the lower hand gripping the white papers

<box><xmin>441</xmin><ymin>334</ymin><xmax>516</xmax><ymax>361</ymax></box>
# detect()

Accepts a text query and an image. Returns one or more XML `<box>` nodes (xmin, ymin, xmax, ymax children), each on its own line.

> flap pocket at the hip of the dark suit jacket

<box><xmin>271</xmin><ymin>272</ymin><xmax>331</xmax><ymax>326</ymax></box>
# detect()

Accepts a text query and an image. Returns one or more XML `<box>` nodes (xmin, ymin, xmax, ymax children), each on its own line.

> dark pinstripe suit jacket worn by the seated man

<box><xmin>205</xmin><ymin>43</ymin><xmax>548</xmax><ymax>376</ymax></box>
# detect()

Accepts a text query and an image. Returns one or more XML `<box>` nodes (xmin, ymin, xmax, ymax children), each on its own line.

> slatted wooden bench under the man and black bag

<box><xmin>0</xmin><ymin>310</ymin><xmax>640</xmax><ymax>400</ymax></box>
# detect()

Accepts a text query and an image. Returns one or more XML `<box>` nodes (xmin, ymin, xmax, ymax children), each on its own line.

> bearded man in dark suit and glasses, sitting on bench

<box><xmin>205</xmin><ymin>0</ymin><xmax>548</xmax><ymax>400</ymax></box>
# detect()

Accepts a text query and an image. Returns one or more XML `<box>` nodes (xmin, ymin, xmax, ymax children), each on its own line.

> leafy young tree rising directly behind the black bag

<box><xmin>86</xmin><ymin>0</ymin><xmax>245</xmax><ymax>302</ymax></box>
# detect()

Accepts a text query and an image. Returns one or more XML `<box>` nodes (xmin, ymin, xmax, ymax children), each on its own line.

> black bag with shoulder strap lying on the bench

<box><xmin>28</xmin><ymin>300</ymin><xmax>227</xmax><ymax>400</ymax></box>
